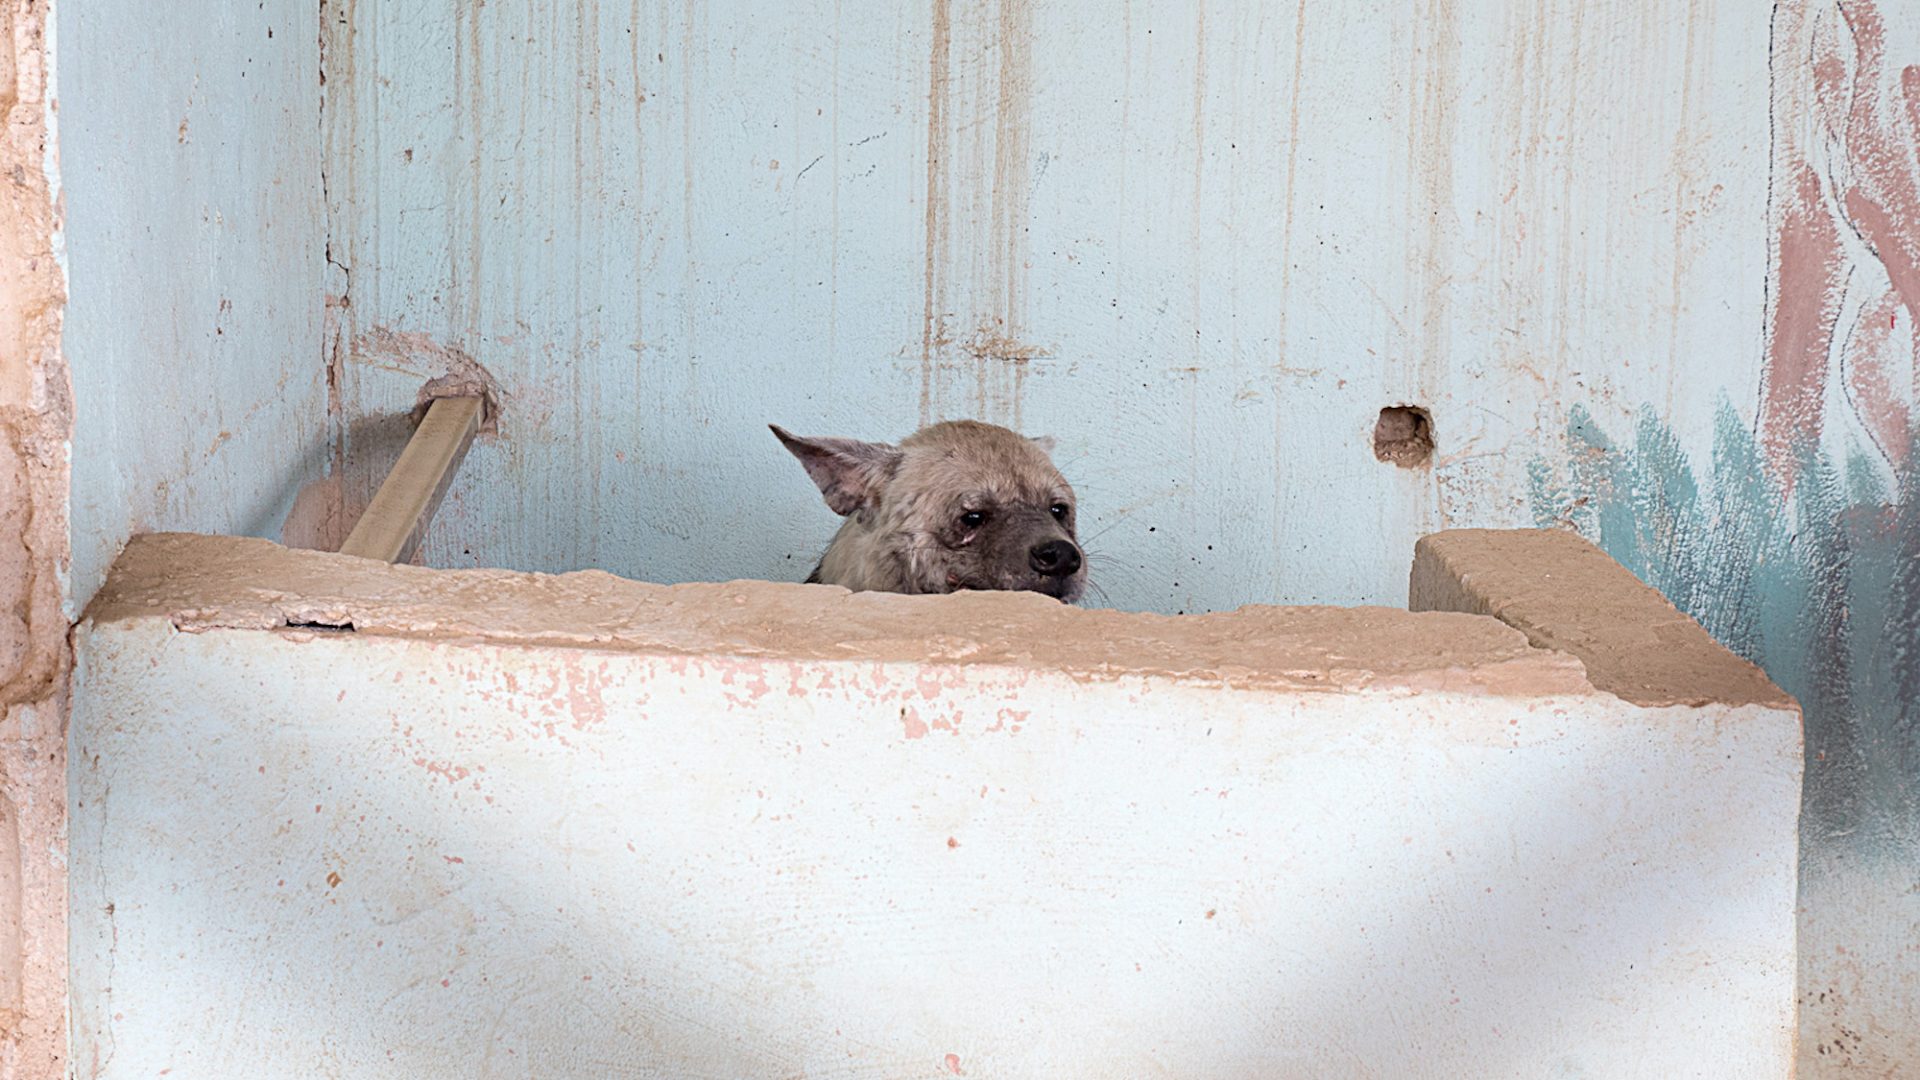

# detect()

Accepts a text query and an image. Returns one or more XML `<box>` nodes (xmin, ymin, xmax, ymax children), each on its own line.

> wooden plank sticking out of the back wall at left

<box><xmin>340</xmin><ymin>398</ymin><xmax>484</xmax><ymax>563</ymax></box>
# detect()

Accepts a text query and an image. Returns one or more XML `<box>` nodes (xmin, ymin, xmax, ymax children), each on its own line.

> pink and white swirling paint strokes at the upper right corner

<box><xmin>1759</xmin><ymin>0</ymin><xmax>1920</xmax><ymax>478</ymax></box>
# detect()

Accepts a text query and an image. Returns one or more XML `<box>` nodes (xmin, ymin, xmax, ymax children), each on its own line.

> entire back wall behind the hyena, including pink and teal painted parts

<box><xmin>324</xmin><ymin>8</ymin><xmax>1920</xmax><ymax>1072</ymax></box>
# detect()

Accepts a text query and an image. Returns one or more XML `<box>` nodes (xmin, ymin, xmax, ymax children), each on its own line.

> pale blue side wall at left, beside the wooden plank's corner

<box><xmin>56</xmin><ymin>0</ymin><xmax>326</xmax><ymax>609</ymax></box>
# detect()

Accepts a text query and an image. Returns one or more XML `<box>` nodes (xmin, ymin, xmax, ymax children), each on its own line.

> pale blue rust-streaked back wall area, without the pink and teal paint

<box><xmin>328</xmin><ymin>0</ymin><xmax>1768</xmax><ymax>613</ymax></box>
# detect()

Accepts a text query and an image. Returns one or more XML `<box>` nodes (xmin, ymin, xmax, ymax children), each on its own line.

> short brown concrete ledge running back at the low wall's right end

<box><xmin>1407</xmin><ymin>528</ymin><xmax>1799</xmax><ymax>713</ymax></box>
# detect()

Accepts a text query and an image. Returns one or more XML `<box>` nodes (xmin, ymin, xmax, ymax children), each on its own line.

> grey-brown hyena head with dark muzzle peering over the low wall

<box><xmin>774</xmin><ymin>421</ymin><xmax>1087</xmax><ymax>603</ymax></box>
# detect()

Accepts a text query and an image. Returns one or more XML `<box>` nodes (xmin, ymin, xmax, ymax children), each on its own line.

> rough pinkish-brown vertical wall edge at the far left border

<box><xmin>0</xmin><ymin>0</ymin><xmax>73</xmax><ymax>1078</ymax></box>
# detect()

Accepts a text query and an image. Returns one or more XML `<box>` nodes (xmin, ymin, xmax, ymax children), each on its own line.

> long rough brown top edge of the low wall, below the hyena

<box><xmin>84</xmin><ymin>534</ymin><xmax>1596</xmax><ymax>698</ymax></box>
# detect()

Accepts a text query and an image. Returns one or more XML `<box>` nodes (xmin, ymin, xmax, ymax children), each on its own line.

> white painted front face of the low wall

<box><xmin>71</xmin><ymin>619</ymin><xmax>1799</xmax><ymax>1080</ymax></box>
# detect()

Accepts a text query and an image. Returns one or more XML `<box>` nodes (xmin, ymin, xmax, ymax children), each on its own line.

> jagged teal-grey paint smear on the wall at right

<box><xmin>1526</xmin><ymin>400</ymin><xmax>1920</xmax><ymax>861</ymax></box>
